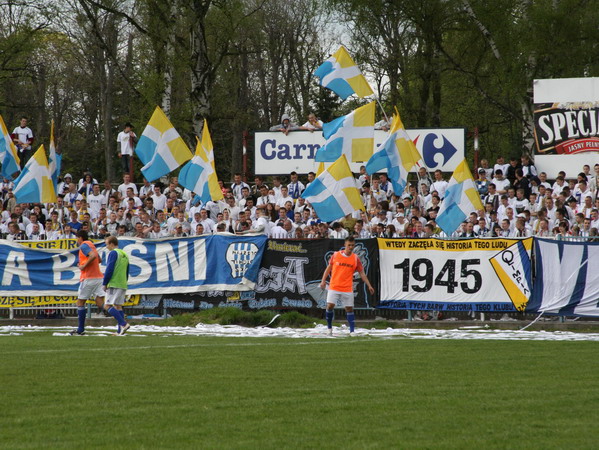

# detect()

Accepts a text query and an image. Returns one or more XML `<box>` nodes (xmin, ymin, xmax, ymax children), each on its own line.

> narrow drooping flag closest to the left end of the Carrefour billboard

<box><xmin>179</xmin><ymin>121</ymin><xmax>223</xmax><ymax>204</ymax></box>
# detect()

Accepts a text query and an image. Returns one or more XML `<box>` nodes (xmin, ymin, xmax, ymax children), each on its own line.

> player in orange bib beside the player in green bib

<box><xmin>70</xmin><ymin>230</ymin><xmax>105</xmax><ymax>336</ymax></box>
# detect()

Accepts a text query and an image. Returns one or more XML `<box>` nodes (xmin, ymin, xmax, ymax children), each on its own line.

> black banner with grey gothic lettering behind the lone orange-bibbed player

<box><xmin>253</xmin><ymin>239</ymin><xmax>378</xmax><ymax>309</ymax></box>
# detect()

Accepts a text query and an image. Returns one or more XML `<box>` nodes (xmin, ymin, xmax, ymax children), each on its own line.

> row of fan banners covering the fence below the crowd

<box><xmin>0</xmin><ymin>234</ymin><xmax>599</xmax><ymax>316</ymax></box>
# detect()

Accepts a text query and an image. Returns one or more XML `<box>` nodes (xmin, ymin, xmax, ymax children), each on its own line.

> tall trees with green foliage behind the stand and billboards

<box><xmin>0</xmin><ymin>0</ymin><xmax>599</xmax><ymax>180</ymax></box>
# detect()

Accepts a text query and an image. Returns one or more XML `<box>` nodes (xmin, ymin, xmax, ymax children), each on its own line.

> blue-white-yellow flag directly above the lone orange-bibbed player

<box><xmin>302</xmin><ymin>155</ymin><xmax>364</xmax><ymax>222</ymax></box>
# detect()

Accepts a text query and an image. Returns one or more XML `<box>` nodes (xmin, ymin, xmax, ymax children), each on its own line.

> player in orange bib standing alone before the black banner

<box><xmin>320</xmin><ymin>236</ymin><xmax>374</xmax><ymax>336</ymax></box>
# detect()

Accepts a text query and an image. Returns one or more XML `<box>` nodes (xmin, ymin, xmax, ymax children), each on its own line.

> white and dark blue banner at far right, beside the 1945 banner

<box><xmin>527</xmin><ymin>238</ymin><xmax>599</xmax><ymax>316</ymax></box>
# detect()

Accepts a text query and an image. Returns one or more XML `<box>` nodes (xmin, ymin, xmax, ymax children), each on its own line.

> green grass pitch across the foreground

<box><xmin>0</xmin><ymin>333</ymin><xmax>599</xmax><ymax>449</ymax></box>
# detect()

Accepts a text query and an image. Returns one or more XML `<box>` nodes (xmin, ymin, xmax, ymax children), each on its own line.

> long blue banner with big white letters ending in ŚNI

<box><xmin>0</xmin><ymin>235</ymin><xmax>267</xmax><ymax>297</ymax></box>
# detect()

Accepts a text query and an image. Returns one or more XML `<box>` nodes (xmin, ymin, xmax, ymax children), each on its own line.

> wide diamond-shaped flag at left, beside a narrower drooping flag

<box><xmin>135</xmin><ymin>106</ymin><xmax>192</xmax><ymax>181</ymax></box>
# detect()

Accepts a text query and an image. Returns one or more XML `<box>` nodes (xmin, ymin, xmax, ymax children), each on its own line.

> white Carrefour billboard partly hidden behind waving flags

<box><xmin>254</xmin><ymin>128</ymin><xmax>466</xmax><ymax>175</ymax></box>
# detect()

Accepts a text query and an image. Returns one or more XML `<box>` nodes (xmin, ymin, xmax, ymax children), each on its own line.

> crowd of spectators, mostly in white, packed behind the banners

<box><xmin>0</xmin><ymin>156</ymin><xmax>599</xmax><ymax>240</ymax></box>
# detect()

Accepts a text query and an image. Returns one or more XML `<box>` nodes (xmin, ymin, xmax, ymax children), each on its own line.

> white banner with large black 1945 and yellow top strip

<box><xmin>378</xmin><ymin>238</ymin><xmax>532</xmax><ymax>312</ymax></box>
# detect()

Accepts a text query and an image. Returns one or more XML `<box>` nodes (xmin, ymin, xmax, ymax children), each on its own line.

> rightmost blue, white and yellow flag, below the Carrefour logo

<box><xmin>437</xmin><ymin>159</ymin><xmax>483</xmax><ymax>236</ymax></box>
